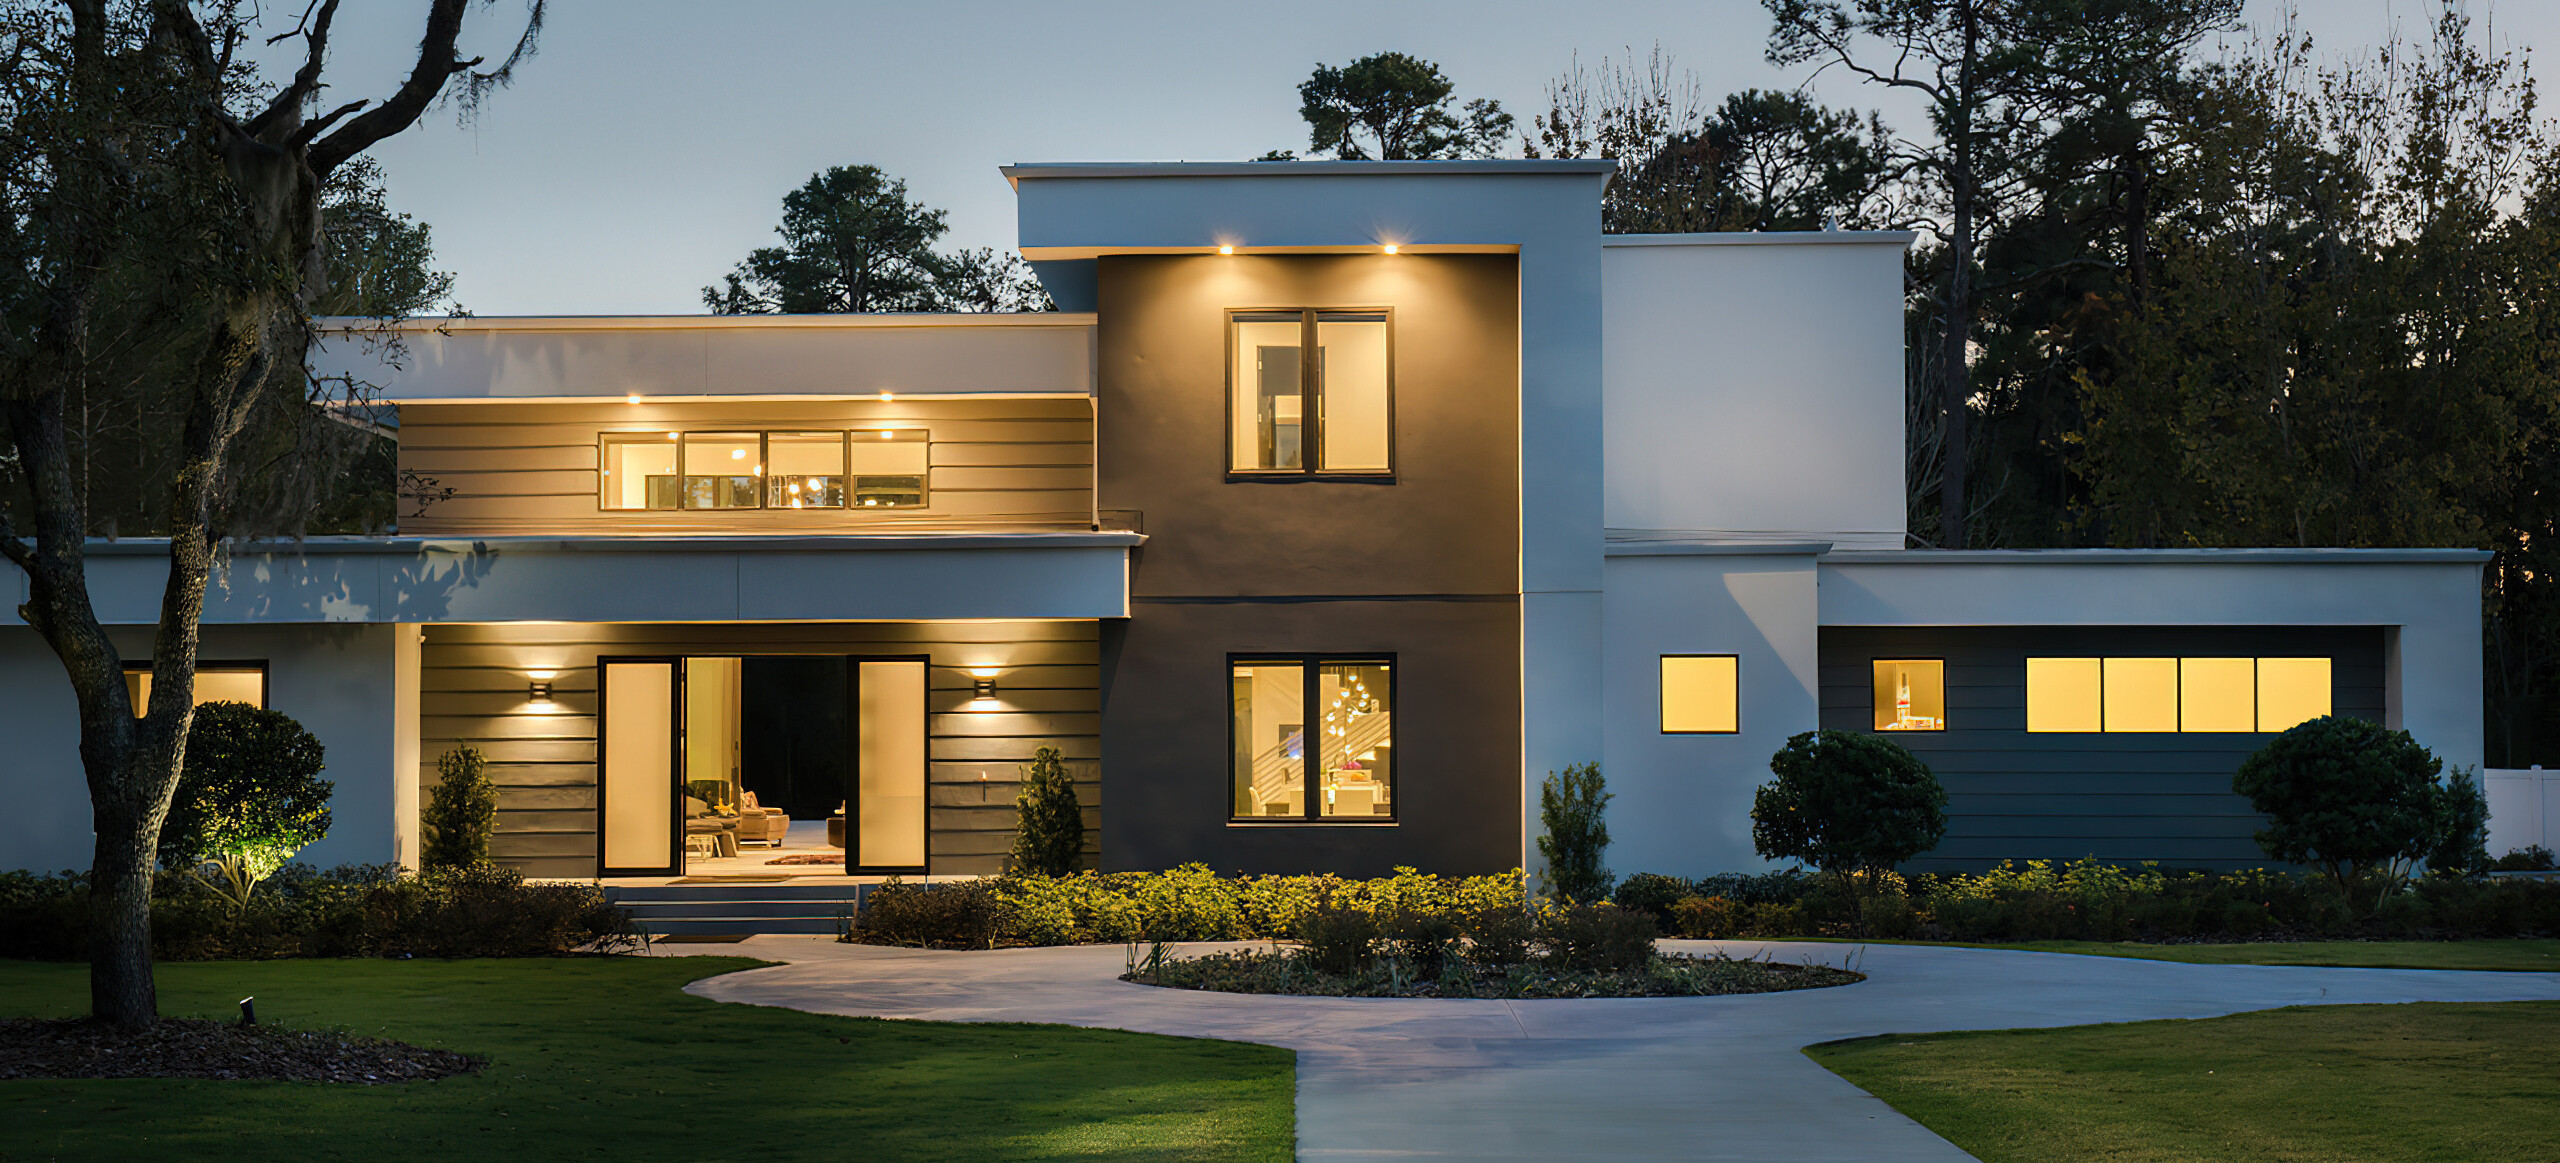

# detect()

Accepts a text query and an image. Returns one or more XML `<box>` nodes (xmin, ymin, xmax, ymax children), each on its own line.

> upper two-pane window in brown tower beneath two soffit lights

<box><xmin>1226</xmin><ymin>310</ymin><xmax>1395</xmax><ymax>476</ymax></box>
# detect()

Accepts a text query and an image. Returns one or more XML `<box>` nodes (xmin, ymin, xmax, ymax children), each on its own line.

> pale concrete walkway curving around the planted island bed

<box><xmin>686</xmin><ymin>938</ymin><xmax>2560</xmax><ymax>1163</ymax></box>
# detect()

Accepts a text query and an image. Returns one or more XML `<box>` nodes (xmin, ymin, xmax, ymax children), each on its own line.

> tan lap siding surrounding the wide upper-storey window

<box><xmin>399</xmin><ymin>397</ymin><xmax>1093</xmax><ymax>535</ymax></box>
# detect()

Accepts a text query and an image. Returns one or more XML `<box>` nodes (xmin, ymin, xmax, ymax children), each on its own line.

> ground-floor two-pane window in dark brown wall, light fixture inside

<box><xmin>1229</xmin><ymin>656</ymin><xmax>1395</xmax><ymax>822</ymax></box>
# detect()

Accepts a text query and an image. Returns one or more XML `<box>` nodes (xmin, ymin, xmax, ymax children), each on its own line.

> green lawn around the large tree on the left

<box><xmin>0</xmin><ymin>958</ymin><xmax>1295</xmax><ymax>1163</ymax></box>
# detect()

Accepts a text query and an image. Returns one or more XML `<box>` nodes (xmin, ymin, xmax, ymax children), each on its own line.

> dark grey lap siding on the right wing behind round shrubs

<box><xmin>1820</xmin><ymin>628</ymin><xmax>2383</xmax><ymax>871</ymax></box>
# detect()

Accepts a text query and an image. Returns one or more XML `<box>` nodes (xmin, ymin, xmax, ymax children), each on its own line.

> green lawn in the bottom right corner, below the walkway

<box><xmin>1805</xmin><ymin>1002</ymin><xmax>2560</xmax><ymax>1163</ymax></box>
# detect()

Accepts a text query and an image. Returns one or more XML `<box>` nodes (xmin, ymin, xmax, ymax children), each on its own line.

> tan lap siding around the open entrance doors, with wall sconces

<box><xmin>417</xmin><ymin>622</ymin><xmax>1101</xmax><ymax>876</ymax></box>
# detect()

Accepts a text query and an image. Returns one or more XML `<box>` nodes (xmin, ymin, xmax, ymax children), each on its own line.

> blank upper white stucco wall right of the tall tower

<box><xmin>1600</xmin><ymin>231</ymin><xmax>1910</xmax><ymax>548</ymax></box>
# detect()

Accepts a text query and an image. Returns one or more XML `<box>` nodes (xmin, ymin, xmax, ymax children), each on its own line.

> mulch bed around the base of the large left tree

<box><xmin>0</xmin><ymin>1017</ymin><xmax>489</xmax><ymax>1086</ymax></box>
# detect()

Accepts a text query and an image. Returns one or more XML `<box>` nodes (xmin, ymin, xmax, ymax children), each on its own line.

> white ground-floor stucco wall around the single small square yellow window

<box><xmin>1600</xmin><ymin>548</ymin><xmax>1820</xmax><ymax>876</ymax></box>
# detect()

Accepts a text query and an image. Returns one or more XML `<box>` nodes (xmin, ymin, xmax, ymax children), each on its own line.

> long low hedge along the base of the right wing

<box><xmin>1618</xmin><ymin>861</ymin><xmax>2560</xmax><ymax>943</ymax></box>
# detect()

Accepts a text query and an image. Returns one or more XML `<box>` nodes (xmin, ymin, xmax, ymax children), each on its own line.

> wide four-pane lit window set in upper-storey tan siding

<box><xmin>599</xmin><ymin>428</ymin><xmax>929</xmax><ymax>510</ymax></box>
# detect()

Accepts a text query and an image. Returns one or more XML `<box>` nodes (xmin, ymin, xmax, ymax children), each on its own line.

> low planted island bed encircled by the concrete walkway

<box><xmin>1121</xmin><ymin>950</ymin><xmax>1866</xmax><ymax>996</ymax></box>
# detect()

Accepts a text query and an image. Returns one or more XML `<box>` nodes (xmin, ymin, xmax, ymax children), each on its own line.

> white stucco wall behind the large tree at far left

<box><xmin>0</xmin><ymin>625</ymin><xmax>417</xmax><ymax>871</ymax></box>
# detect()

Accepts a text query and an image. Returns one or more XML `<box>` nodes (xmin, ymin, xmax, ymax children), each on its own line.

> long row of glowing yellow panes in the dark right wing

<box><xmin>2028</xmin><ymin>658</ymin><xmax>2332</xmax><ymax>735</ymax></box>
